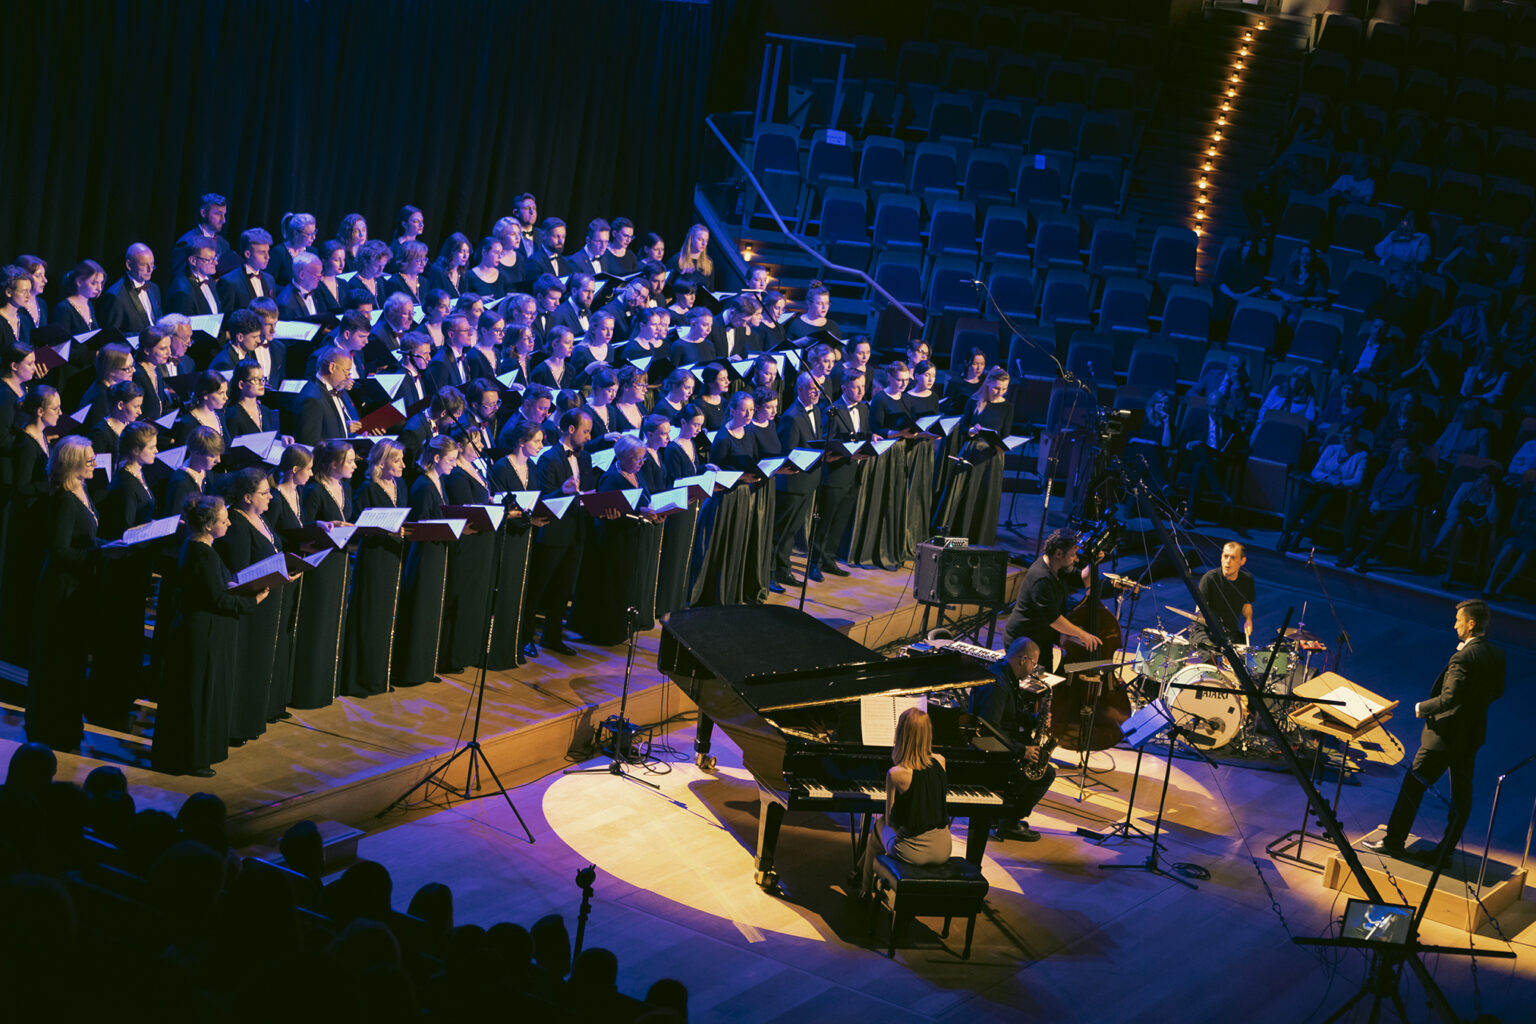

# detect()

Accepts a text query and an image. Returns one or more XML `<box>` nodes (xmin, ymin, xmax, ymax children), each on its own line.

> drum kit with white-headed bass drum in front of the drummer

<box><xmin>1129</xmin><ymin>605</ymin><xmax>1327</xmax><ymax>755</ymax></box>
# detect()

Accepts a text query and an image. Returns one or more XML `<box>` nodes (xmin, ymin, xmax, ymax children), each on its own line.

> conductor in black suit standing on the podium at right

<box><xmin>1361</xmin><ymin>600</ymin><xmax>1504</xmax><ymax>861</ymax></box>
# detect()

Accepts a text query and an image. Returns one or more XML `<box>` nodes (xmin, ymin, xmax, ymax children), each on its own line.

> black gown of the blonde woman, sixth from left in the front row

<box><xmin>332</xmin><ymin>481</ymin><xmax>409</xmax><ymax>697</ymax></box>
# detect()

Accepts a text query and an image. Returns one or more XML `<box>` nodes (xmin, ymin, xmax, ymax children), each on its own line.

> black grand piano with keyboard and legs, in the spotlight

<box><xmin>657</xmin><ymin>605</ymin><xmax>1023</xmax><ymax>892</ymax></box>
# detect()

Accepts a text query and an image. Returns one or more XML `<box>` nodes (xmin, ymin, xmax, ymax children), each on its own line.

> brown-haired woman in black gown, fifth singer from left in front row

<box><xmin>289</xmin><ymin>441</ymin><xmax>358</xmax><ymax>709</ymax></box>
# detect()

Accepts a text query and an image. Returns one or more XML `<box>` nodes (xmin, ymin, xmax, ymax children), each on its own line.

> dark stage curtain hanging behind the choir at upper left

<box><xmin>0</xmin><ymin>0</ymin><xmax>734</xmax><ymax>288</ymax></box>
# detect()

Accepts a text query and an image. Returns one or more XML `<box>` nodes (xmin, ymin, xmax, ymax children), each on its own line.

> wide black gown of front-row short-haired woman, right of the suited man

<box><xmin>570</xmin><ymin>462</ymin><xmax>662</xmax><ymax>646</ymax></box>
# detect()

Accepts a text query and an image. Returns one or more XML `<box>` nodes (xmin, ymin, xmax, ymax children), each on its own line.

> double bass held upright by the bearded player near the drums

<box><xmin>1051</xmin><ymin>536</ymin><xmax>1130</xmax><ymax>751</ymax></box>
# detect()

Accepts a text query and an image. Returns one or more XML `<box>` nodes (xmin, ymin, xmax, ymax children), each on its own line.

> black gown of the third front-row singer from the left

<box><xmin>214</xmin><ymin>510</ymin><xmax>287</xmax><ymax>740</ymax></box>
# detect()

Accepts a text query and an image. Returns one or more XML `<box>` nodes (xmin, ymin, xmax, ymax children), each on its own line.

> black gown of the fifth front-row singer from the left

<box><xmin>289</xmin><ymin>479</ymin><xmax>352</xmax><ymax>709</ymax></box>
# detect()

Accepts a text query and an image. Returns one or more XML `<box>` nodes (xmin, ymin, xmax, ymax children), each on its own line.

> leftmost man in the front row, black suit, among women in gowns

<box><xmin>522</xmin><ymin>408</ymin><xmax>592</xmax><ymax>657</ymax></box>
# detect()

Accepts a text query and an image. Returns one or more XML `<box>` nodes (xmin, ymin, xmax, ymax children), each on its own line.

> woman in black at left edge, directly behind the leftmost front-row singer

<box><xmin>0</xmin><ymin>384</ymin><xmax>63</xmax><ymax>666</ymax></box>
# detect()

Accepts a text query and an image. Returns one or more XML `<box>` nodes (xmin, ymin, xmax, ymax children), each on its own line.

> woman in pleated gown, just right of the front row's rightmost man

<box><xmin>848</xmin><ymin>359</ymin><xmax>915</xmax><ymax>570</ymax></box>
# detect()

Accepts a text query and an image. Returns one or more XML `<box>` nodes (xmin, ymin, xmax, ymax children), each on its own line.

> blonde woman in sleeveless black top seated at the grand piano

<box><xmin>859</xmin><ymin>708</ymin><xmax>949</xmax><ymax>898</ymax></box>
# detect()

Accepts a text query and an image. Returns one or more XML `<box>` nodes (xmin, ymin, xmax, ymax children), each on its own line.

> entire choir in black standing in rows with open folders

<box><xmin>9</xmin><ymin>214</ymin><xmax>1032</xmax><ymax>777</ymax></box>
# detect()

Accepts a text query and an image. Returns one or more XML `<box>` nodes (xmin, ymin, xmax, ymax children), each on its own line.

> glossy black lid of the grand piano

<box><xmin>657</xmin><ymin>605</ymin><xmax>992</xmax><ymax>712</ymax></box>
